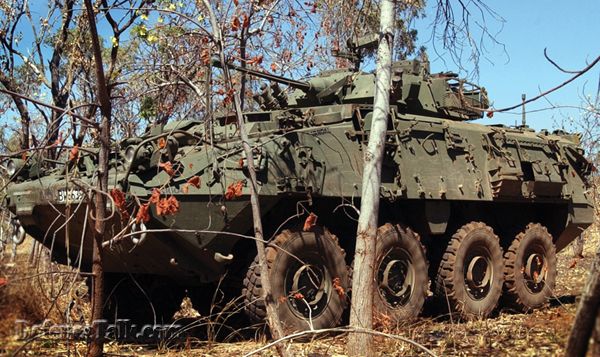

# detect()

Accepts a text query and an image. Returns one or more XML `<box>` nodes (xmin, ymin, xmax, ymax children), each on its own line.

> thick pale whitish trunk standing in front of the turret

<box><xmin>347</xmin><ymin>0</ymin><xmax>395</xmax><ymax>356</ymax></box>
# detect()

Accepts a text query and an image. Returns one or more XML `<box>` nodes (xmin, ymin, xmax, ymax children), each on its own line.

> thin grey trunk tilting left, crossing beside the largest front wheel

<box><xmin>203</xmin><ymin>0</ymin><xmax>287</xmax><ymax>356</ymax></box>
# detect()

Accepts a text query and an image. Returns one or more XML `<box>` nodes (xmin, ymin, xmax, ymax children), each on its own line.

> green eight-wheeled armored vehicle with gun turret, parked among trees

<box><xmin>5</xmin><ymin>43</ymin><xmax>592</xmax><ymax>332</ymax></box>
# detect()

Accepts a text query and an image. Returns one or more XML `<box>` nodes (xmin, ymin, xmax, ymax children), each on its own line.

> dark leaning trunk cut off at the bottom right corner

<box><xmin>565</xmin><ymin>241</ymin><xmax>600</xmax><ymax>357</ymax></box>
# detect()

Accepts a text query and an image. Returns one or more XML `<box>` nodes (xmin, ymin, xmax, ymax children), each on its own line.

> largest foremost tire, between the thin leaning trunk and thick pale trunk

<box><xmin>242</xmin><ymin>228</ymin><xmax>349</xmax><ymax>334</ymax></box>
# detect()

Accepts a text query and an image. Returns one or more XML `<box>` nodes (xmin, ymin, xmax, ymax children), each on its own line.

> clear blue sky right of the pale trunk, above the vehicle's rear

<box><xmin>415</xmin><ymin>0</ymin><xmax>600</xmax><ymax>130</ymax></box>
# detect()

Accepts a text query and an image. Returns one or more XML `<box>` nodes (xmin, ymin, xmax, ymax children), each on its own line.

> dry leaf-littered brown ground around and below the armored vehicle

<box><xmin>0</xmin><ymin>229</ymin><xmax>600</xmax><ymax>357</ymax></box>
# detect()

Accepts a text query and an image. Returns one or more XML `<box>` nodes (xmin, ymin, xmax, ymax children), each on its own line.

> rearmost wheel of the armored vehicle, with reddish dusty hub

<box><xmin>504</xmin><ymin>223</ymin><xmax>556</xmax><ymax>312</ymax></box>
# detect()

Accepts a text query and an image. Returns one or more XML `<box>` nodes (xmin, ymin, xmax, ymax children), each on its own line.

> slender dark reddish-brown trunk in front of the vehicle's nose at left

<box><xmin>85</xmin><ymin>0</ymin><xmax>112</xmax><ymax>356</ymax></box>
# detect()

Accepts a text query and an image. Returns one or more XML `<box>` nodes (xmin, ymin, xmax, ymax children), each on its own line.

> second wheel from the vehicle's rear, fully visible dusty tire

<box><xmin>436</xmin><ymin>222</ymin><xmax>504</xmax><ymax>320</ymax></box>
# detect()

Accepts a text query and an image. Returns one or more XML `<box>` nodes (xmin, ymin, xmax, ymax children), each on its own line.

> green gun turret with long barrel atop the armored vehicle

<box><xmin>218</xmin><ymin>52</ymin><xmax>489</xmax><ymax>120</ymax></box>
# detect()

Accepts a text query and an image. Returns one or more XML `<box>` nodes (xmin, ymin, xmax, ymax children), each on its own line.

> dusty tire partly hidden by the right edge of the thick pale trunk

<box><xmin>373</xmin><ymin>223</ymin><xmax>429</xmax><ymax>326</ymax></box>
